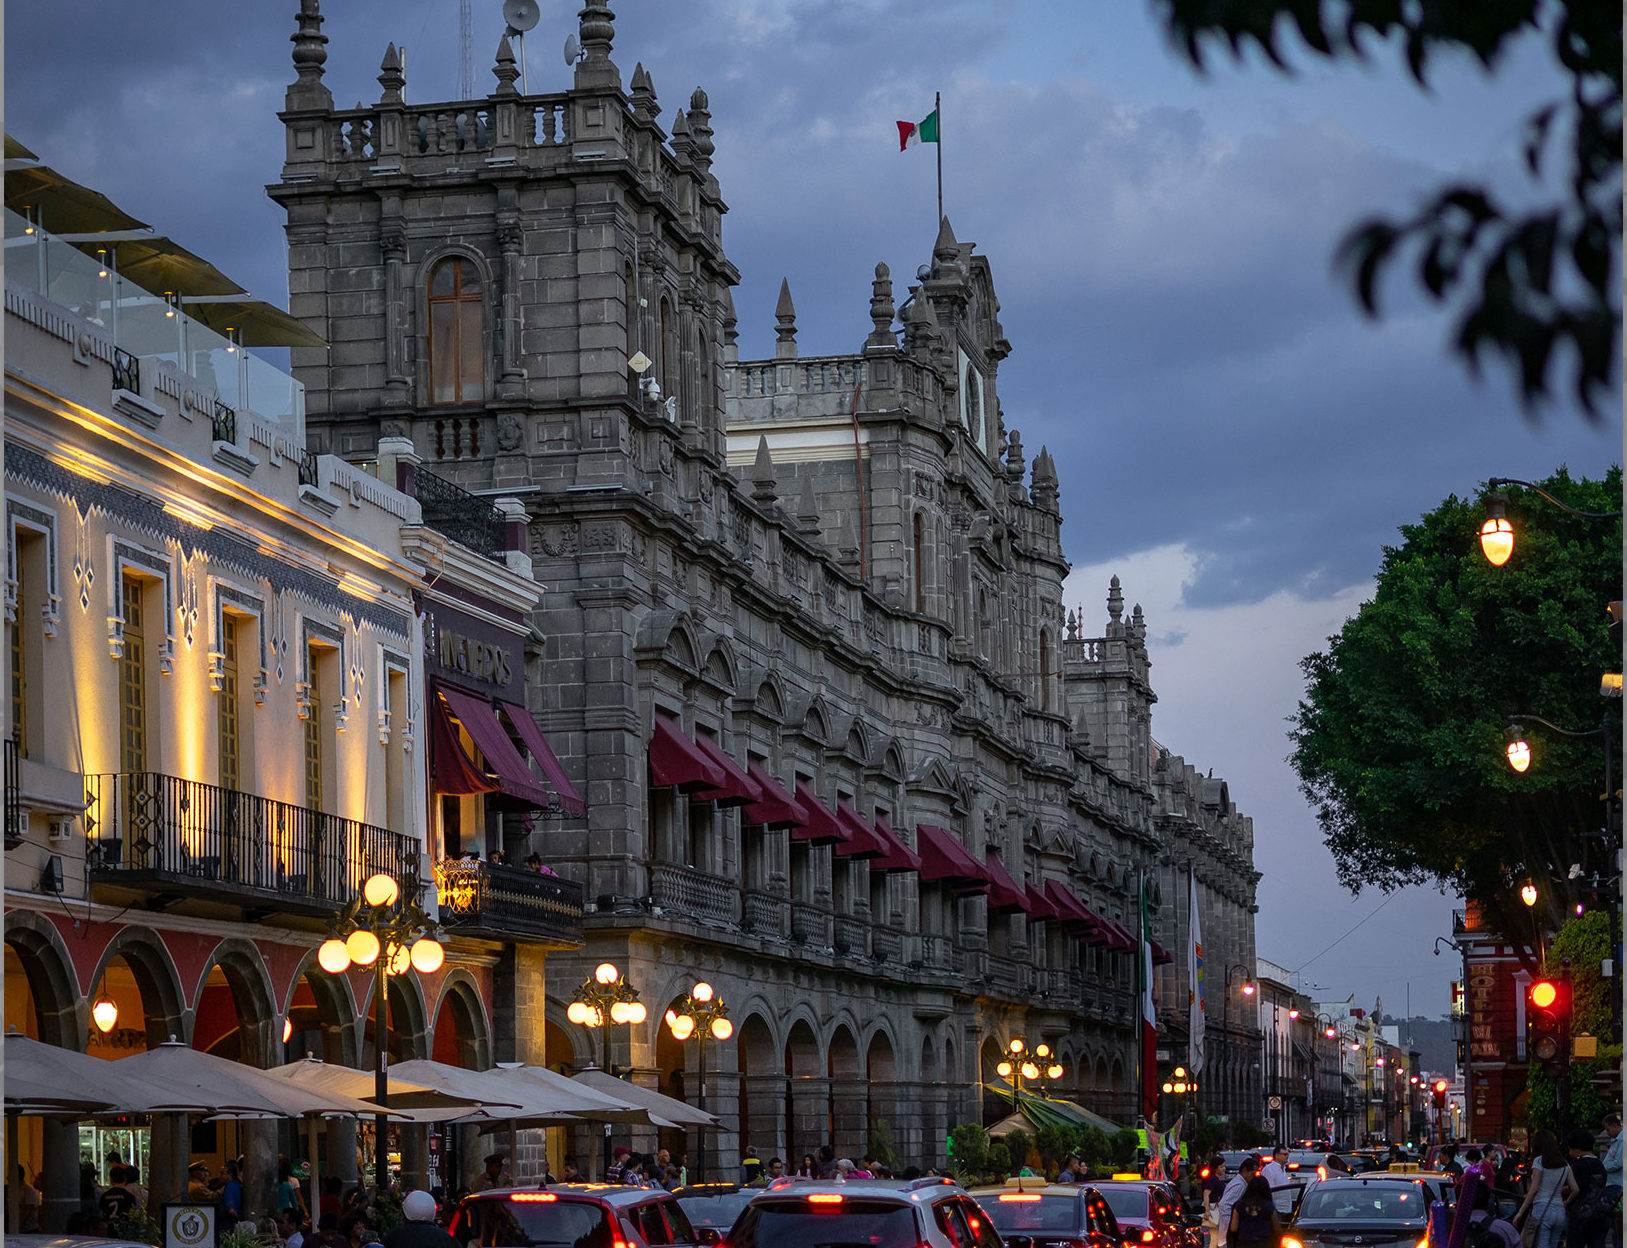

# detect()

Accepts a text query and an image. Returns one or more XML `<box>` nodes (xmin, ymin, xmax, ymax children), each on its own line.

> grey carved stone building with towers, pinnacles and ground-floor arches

<box><xmin>270</xmin><ymin>0</ymin><xmax>1258</xmax><ymax>1165</ymax></box>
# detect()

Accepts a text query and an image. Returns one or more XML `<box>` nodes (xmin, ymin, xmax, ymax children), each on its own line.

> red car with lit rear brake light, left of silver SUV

<box><xmin>449</xmin><ymin>1183</ymin><xmax>702</xmax><ymax>1248</ymax></box>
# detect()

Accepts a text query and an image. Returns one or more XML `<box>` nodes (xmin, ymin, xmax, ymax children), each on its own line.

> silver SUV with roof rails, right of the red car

<box><xmin>722</xmin><ymin>1178</ymin><xmax>1004</xmax><ymax>1248</ymax></box>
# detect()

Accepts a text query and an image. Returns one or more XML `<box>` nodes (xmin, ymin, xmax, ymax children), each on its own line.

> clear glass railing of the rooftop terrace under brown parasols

<box><xmin>5</xmin><ymin>208</ymin><xmax>304</xmax><ymax>444</ymax></box>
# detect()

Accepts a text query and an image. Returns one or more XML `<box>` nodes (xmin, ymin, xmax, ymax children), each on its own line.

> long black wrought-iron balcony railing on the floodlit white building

<box><xmin>85</xmin><ymin>771</ymin><xmax>420</xmax><ymax>910</ymax></box>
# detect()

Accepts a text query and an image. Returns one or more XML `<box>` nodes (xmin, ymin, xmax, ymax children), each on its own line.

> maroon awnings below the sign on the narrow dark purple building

<box><xmin>430</xmin><ymin>682</ymin><xmax>587</xmax><ymax>815</ymax></box>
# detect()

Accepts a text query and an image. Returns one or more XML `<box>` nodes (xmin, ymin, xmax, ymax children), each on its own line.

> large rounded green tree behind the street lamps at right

<box><xmin>1289</xmin><ymin>467</ymin><xmax>1622</xmax><ymax>970</ymax></box>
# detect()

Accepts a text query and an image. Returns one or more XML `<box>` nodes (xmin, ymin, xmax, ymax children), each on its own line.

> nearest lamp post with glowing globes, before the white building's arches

<box><xmin>316</xmin><ymin>871</ymin><xmax>446</xmax><ymax>1191</ymax></box>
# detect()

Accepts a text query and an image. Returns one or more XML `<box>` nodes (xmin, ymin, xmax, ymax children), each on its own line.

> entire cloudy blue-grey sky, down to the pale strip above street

<box><xmin>5</xmin><ymin>0</ymin><xmax>1620</xmax><ymax>1014</ymax></box>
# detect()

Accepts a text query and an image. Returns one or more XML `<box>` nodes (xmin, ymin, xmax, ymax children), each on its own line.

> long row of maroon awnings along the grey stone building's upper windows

<box><xmin>649</xmin><ymin>714</ymin><xmax>1175</xmax><ymax>965</ymax></box>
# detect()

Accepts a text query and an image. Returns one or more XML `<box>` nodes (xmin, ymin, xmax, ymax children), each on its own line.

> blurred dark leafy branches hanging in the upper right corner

<box><xmin>1154</xmin><ymin>0</ymin><xmax>1622</xmax><ymax>418</ymax></box>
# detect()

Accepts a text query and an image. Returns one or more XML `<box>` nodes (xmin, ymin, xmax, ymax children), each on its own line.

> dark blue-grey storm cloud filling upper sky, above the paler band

<box><xmin>7</xmin><ymin>0</ymin><xmax>1619</xmax><ymax>605</ymax></box>
